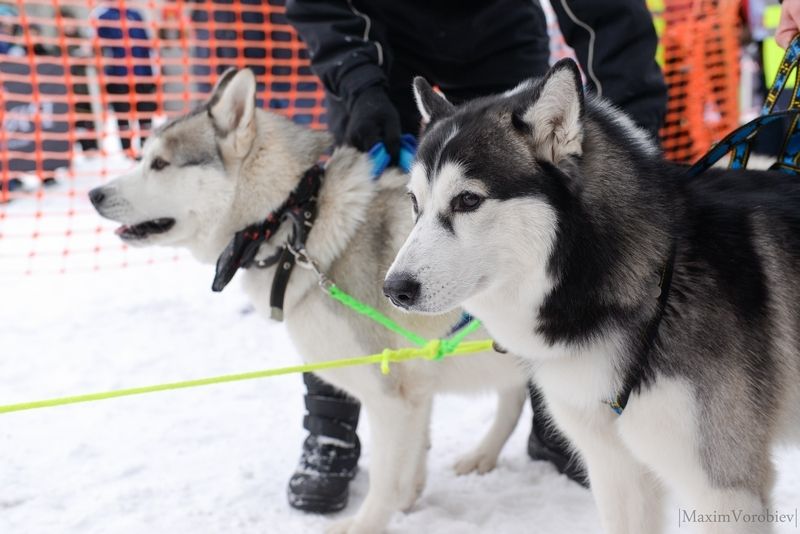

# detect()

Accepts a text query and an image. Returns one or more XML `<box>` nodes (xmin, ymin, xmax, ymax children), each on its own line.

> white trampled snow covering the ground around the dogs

<box><xmin>0</xmin><ymin>157</ymin><xmax>800</xmax><ymax>534</ymax></box>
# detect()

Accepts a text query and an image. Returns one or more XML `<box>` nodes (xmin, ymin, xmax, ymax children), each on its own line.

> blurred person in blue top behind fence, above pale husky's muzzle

<box><xmin>91</xmin><ymin>0</ymin><xmax>157</xmax><ymax>156</ymax></box>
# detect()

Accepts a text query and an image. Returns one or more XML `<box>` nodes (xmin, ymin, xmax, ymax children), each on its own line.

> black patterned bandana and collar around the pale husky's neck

<box><xmin>211</xmin><ymin>164</ymin><xmax>325</xmax><ymax>321</ymax></box>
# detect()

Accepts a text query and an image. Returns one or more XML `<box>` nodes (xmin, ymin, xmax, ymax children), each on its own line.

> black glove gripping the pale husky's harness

<box><xmin>344</xmin><ymin>86</ymin><xmax>400</xmax><ymax>162</ymax></box>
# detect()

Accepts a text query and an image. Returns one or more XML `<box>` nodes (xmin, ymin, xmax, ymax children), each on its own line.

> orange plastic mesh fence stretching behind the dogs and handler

<box><xmin>0</xmin><ymin>0</ymin><xmax>738</xmax><ymax>277</ymax></box>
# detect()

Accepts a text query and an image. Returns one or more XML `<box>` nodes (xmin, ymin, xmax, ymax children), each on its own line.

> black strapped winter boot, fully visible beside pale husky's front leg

<box><xmin>287</xmin><ymin>373</ymin><xmax>361</xmax><ymax>514</ymax></box>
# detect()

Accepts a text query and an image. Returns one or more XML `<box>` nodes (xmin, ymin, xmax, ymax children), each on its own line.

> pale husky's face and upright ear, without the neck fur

<box><xmin>89</xmin><ymin>70</ymin><xmax>255</xmax><ymax>246</ymax></box>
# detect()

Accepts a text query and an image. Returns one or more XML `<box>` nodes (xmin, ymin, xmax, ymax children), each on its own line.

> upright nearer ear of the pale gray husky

<box><xmin>207</xmin><ymin>69</ymin><xmax>256</xmax><ymax>157</ymax></box>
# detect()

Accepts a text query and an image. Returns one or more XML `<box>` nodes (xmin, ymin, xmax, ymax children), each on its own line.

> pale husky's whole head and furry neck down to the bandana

<box><xmin>89</xmin><ymin>69</ymin><xmax>322</xmax><ymax>261</ymax></box>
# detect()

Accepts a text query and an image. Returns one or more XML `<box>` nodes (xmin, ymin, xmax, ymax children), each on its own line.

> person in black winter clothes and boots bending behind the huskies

<box><xmin>286</xmin><ymin>0</ymin><xmax>667</xmax><ymax>512</ymax></box>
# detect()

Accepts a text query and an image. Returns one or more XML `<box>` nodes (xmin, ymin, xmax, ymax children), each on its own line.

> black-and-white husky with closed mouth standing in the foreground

<box><xmin>384</xmin><ymin>61</ymin><xmax>800</xmax><ymax>534</ymax></box>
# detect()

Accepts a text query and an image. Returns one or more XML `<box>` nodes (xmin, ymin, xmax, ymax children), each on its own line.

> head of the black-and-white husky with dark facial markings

<box><xmin>384</xmin><ymin>60</ymin><xmax>654</xmax><ymax>316</ymax></box>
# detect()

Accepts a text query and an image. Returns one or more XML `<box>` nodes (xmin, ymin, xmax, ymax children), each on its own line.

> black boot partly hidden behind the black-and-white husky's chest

<box><xmin>528</xmin><ymin>384</ymin><xmax>589</xmax><ymax>488</ymax></box>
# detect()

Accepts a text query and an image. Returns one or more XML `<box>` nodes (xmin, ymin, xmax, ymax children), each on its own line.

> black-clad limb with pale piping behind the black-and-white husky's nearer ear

<box><xmin>551</xmin><ymin>0</ymin><xmax>667</xmax><ymax>137</ymax></box>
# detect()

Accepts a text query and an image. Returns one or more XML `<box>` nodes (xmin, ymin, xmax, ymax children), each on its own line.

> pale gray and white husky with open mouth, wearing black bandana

<box><xmin>90</xmin><ymin>70</ymin><xmax>527</xmax><ymax>533</ymax></box>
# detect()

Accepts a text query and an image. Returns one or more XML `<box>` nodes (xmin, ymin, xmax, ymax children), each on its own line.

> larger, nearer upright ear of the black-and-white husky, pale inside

<box><xmin>521</xmin><ymin>59</ymin><xmax>583</xmax><ymax>165</ymax></box>
